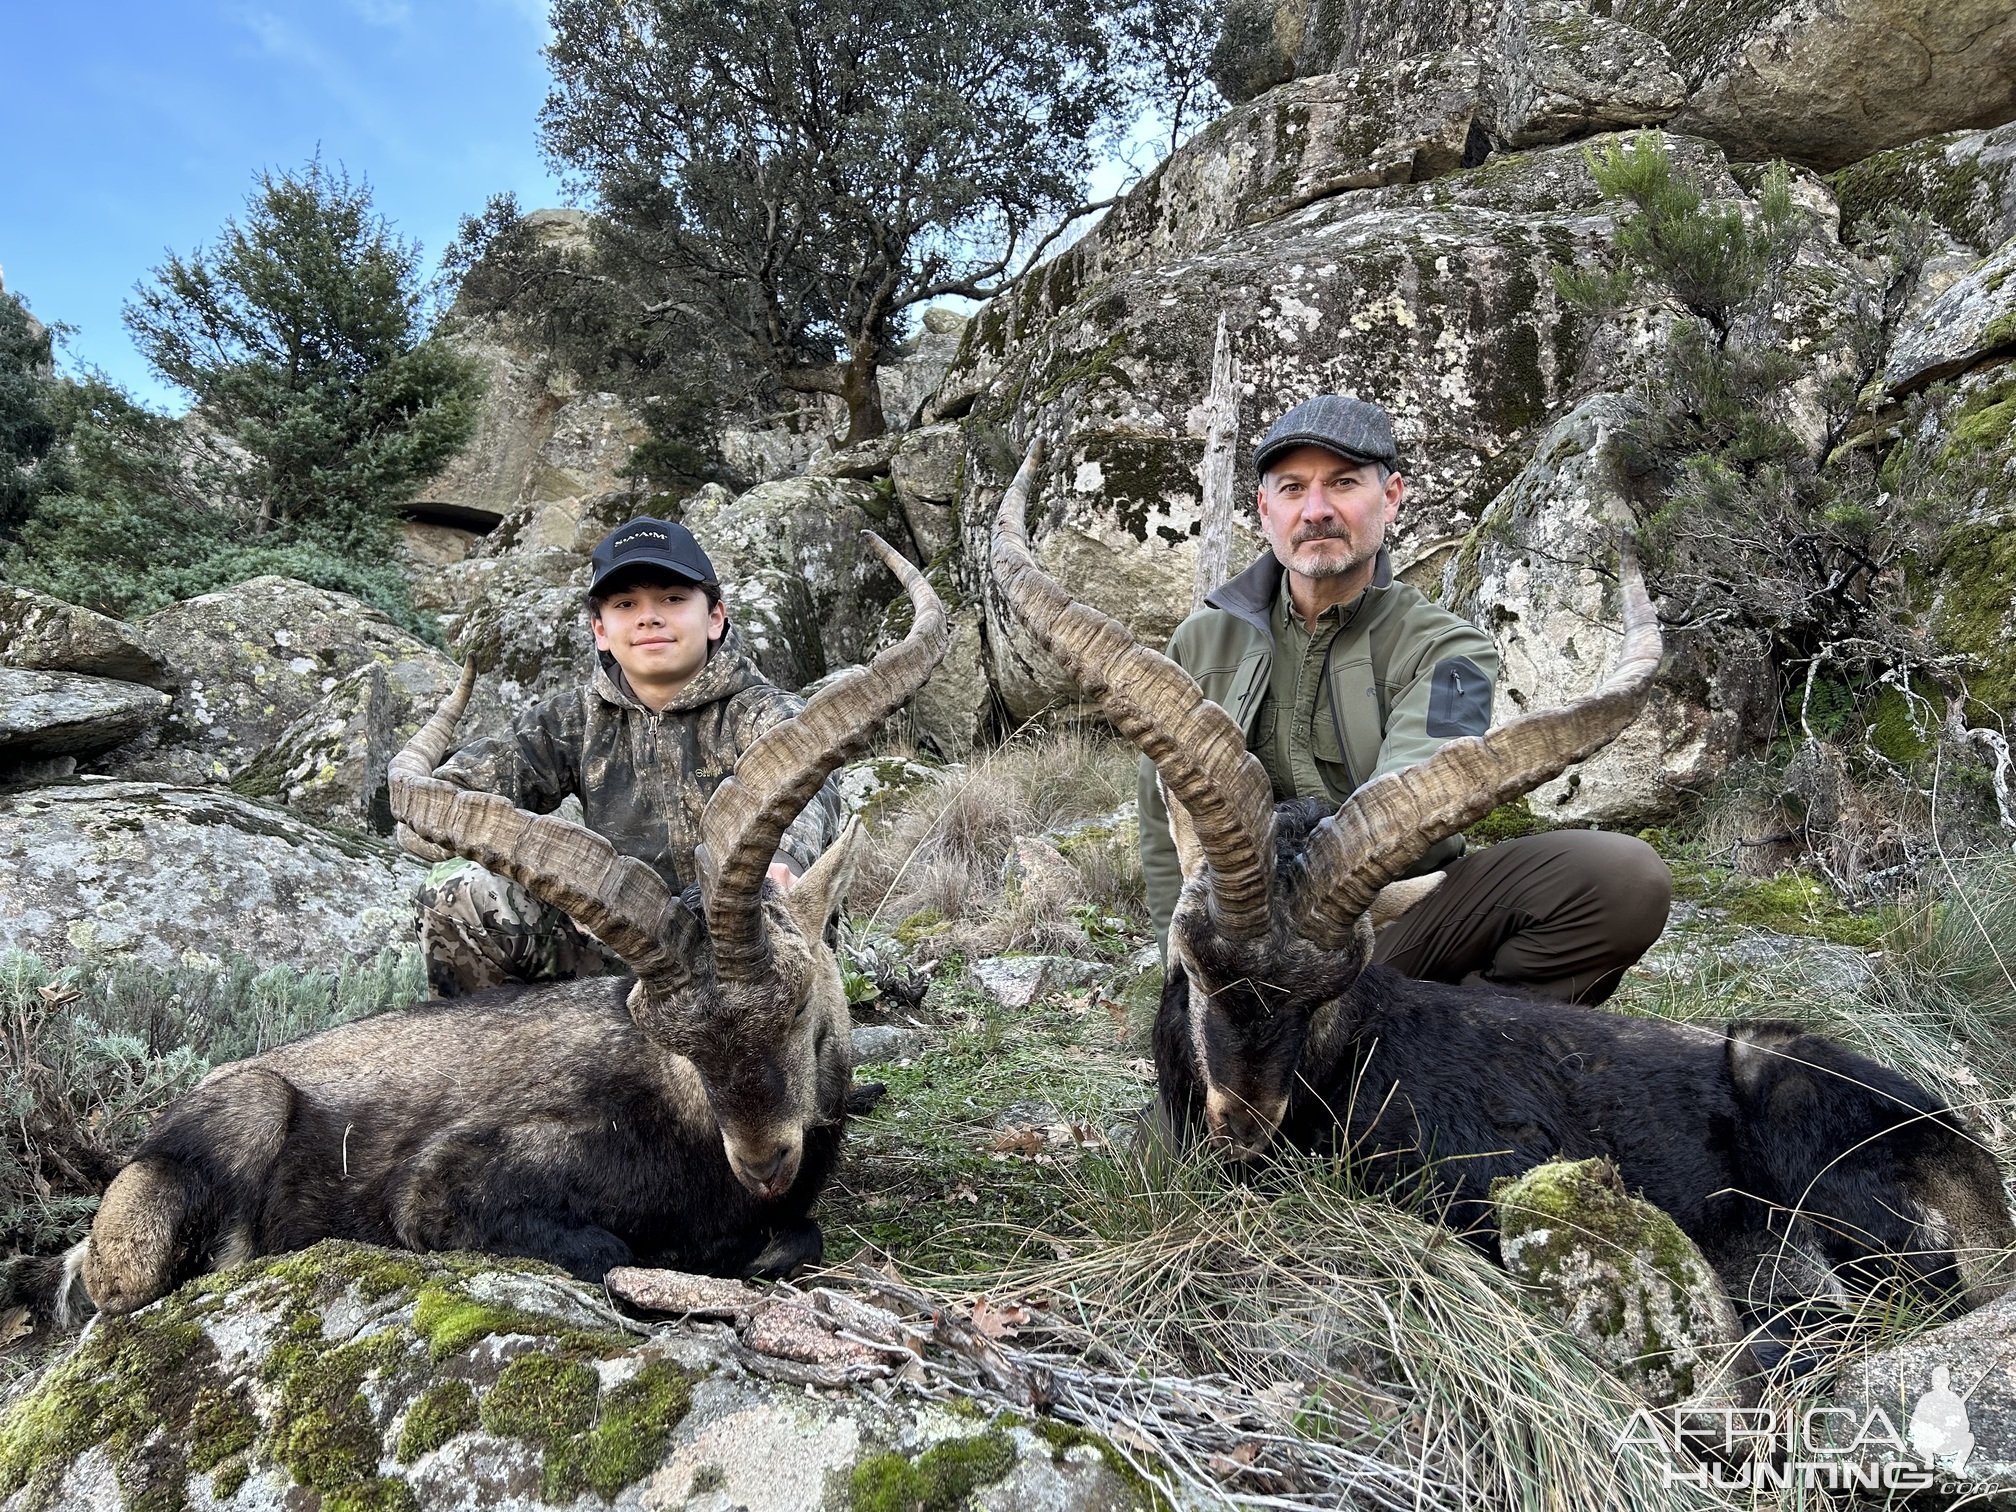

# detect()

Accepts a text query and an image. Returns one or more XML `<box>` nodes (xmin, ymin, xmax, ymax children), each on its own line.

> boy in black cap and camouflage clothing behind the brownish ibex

<box><xmin>419</xmin><ymin>518</ymin><xmax>841</xmax><ymax>998</ymax></box>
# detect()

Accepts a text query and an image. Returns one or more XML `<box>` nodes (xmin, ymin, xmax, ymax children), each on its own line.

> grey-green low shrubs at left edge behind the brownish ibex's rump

<box><xmin>0</xmin><ymin>948</ymin><xmax>427</xmax><ymax>1254</ymax></box>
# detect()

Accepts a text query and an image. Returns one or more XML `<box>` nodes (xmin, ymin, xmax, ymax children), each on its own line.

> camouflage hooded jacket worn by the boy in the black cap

<box><xmin>433</xmin><ymin>625</ymin><xmax>841</xmax><ymax>889</ymax></box>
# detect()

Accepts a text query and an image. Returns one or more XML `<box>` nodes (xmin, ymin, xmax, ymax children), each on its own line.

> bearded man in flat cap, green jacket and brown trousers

<box><xmin>1139</xmin><ymin>393</ymin><xmax>1673</xmax><ymax>1002</ymax></box>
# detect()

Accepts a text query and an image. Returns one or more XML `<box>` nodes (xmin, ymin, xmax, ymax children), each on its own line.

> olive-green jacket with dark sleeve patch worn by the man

<box><xmin>1137</xmin><ymin>550</ymin><xmax>1498</xmax><ymax>958</ymax></box>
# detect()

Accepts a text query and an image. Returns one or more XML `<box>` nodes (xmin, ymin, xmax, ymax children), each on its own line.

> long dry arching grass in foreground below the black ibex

<box><xmin>907</xmin><ymin>1155</ymin><xmax>1714</xmax><ymax>1512</ymax></box>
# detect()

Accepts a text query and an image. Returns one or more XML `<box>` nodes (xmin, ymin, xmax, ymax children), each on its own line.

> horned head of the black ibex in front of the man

<box><xmin>992</xmin><ymin>439</ymin><xmax>1659</xmax><ymax>1155</ymax></box>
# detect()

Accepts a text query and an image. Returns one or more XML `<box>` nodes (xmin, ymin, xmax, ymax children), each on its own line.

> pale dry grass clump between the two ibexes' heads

<box><xmin>853</xmin><ymin>728</ymin><xmax>1145</xmax><ymax>956</ymax></box>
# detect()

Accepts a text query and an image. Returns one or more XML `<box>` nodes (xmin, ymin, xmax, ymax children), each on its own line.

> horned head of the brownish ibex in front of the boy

<box><xmin>391</xmin><ymin>532</ymin><xmax>948</xmax><ymax>1198</ymax></box>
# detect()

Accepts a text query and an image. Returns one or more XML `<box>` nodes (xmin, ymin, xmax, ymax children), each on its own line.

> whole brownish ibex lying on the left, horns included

<box><xmin>53</xmin><ymin>538</ymin><xmax>948</xmax><ymax>1312</ymax></box>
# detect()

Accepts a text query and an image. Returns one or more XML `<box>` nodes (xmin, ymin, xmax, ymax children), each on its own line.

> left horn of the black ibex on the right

<box><xmin>994</xmin><ymin>435</ymin><xmax>1274</xmax><ymax>939</ymax></box>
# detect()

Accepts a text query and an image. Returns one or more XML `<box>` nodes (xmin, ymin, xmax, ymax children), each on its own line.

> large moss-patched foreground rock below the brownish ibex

<box><xmin>0</xmin><ymin>1242</ymin><xmax>1187</xmax><ymax>1512</ymax></box>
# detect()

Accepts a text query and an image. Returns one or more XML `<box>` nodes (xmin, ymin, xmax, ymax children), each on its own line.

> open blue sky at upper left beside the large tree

<box><xmin>0</xmin><ymin>0</ymin><xmax>562</xmax><ymax>409</ymax></box>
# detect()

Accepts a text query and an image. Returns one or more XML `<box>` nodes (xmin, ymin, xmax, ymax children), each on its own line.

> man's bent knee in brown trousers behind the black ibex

<box><xmin>1373</xmin><ymin>829</ymin><xmax>1673</xmax><ymax>1002</ymax></box>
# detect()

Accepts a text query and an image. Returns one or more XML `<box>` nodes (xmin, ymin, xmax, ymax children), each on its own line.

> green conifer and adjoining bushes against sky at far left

<box><xmin>4</xmin><ymin>161</ymin><xmax>480</xmax><ymax>637</ymax></box>
